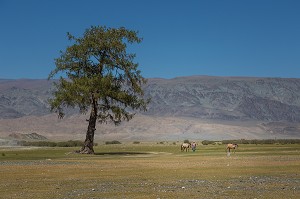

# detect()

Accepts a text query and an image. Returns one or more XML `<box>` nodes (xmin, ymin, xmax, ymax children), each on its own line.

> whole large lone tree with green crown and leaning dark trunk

<box><xmin>49</xmin><ymin>26</ymin><xmax>149</xmax><ymax>154</ymax></box>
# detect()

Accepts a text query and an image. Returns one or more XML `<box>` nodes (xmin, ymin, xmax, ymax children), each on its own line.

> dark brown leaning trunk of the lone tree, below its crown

<box><xmin>78</xmin><ymin>98</ymin><xmax>97</xmax><ymax>154</ymax></box>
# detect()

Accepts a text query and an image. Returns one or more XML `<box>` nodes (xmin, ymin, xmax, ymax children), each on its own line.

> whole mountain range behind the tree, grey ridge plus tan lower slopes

<box><xmin>0</xmin><ymin>76</ymin><xmax>300</xmax><ymax>140</ymax></box>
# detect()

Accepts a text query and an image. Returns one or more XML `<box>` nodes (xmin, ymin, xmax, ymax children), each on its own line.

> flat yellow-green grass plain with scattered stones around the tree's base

<box><xmin>0</xmin><ymin>142</ymin><xmax>300</xmax><ymax>199</ymax></box>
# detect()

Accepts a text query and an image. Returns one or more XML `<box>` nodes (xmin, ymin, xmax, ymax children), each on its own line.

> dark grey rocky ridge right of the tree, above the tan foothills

<box><xmin>146</xmin><ymin>76</ymin><xmax>300</xmax><ymax>122</ymax></box>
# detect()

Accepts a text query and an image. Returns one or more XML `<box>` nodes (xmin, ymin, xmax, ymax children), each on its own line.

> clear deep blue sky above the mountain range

<box><xmin>0</xmin><ymin>0</ymin><xmax>300</xmax><ymax>79</ymax></box>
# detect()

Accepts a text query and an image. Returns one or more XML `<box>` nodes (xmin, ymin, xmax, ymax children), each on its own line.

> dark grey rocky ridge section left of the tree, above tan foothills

<box><xmin>0</xmin><ymin>79</ymin><xmax>52</xmax><ymax>119</ymax></box>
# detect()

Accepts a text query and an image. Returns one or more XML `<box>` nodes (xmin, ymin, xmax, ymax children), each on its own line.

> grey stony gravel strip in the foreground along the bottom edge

<box><xmin>51</xmin><ymin>176</ymin><xmax>300</xmax><ymax>199</ymax></box>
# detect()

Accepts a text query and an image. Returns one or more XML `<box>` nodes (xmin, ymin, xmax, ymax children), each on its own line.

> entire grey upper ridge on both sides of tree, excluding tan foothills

<box><xmin>0</xmin><ymin>76</ymin><xmax>300</xmax><ymax>122</ymax></box>
